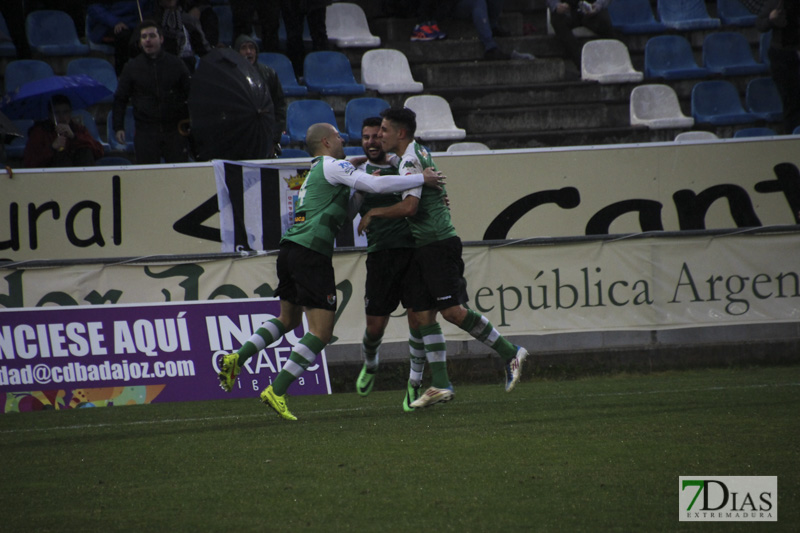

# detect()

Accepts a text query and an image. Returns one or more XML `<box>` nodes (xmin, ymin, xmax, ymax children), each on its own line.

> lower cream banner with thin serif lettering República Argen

<box><xmin>0</xmin><ymin>231</ymin><xmax>800</xmax><ymax>344</ymax></box>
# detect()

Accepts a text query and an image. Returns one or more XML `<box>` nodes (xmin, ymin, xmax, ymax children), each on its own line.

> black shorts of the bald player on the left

<box><xmin>275</xmin><ymin>242</ymin><xmax>336</xmax><ymax>311</ymax></box>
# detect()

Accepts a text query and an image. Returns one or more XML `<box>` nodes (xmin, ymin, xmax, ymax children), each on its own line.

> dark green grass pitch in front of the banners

<box><xmin>0</xmin><ymin>366</ymin><xmax>800</xmax><ymax>532</ymax></box>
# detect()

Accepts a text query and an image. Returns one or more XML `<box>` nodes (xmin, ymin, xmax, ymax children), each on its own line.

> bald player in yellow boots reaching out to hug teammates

<box><xmin>219</xmin><ymin>123</ymin><xmax>443</xmax><ymax>420</ymax></box>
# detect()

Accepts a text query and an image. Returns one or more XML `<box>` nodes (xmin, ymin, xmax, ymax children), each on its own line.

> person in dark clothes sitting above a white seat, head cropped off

<box><xmin>547</xmin><ymin>0</ymin><xmax>617</xmax><ymax>71</ymax></box>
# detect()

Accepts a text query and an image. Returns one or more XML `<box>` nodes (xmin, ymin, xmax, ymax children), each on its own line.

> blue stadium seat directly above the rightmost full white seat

<box><xmin>644</xmin><ymin>35</ymin><xmax>710</xmax><ymax>80</ymax></box>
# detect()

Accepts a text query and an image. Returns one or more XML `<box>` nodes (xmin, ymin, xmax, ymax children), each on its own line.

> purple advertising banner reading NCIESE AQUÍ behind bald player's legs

<box><xmin>0</xmin><ymin>298</ymin><xmax>331</xmax><ymax>413</ymax></box>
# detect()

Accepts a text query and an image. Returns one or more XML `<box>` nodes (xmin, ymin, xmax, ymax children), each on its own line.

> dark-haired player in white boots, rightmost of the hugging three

<box><xmin>359</xmin><ymin>108</ymin><xmax>528</xmax><ymax>408</ymax></box>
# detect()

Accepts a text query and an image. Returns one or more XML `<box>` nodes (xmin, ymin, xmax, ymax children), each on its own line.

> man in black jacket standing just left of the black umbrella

<box><xmin>112</xmin><ymin>20</ymin><xmax>189</xmax><ymax>165</ymax></box>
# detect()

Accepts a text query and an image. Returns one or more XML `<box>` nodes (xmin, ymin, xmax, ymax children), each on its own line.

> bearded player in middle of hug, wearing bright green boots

<box><xmin>356</xmin><ymin>117</ymin><xmax>425</xmax><ymax>412</ymax></box>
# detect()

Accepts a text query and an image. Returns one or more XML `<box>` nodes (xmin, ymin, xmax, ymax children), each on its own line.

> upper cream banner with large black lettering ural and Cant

<box><xmin>0</xmin><ymin>136</ymin><xmax>800</xmax><ymax>261</ymax></box>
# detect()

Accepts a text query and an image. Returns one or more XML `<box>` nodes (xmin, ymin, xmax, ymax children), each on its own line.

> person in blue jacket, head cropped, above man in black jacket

<box><xmin>86</xmin><ymin>0</ymin><xmax>151</xmax><ymax>76</ymax></box>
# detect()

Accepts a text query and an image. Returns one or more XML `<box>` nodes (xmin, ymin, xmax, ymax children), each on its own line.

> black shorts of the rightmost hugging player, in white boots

<box><xmin>405</xmin><ymin>237</ymin><xmax>469</xmax><ymax>311</ymax></box>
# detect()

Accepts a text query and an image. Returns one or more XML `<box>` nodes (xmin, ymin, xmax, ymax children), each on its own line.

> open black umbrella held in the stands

<box><xmin>189</xmin><ymin>48</ymin><xmax>275</xmax><ymax>160</ymax></box>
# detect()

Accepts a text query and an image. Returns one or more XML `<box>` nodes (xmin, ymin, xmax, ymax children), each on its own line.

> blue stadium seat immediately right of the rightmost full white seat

<box><xmin>692</xmin><ymin>80</ymin><xmax>756</xmax><ymax>126</ymax></box>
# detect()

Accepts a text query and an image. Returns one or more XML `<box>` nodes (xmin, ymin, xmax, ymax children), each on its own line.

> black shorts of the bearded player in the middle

<box><xmin>364</xmin><ymin>248</ymin><xmax>414</xmax><ymax>316</ymax></box>
